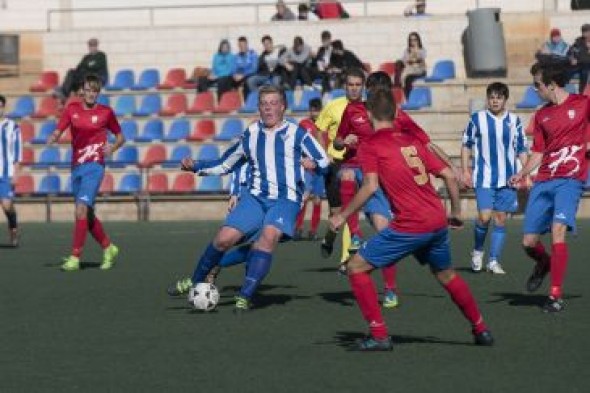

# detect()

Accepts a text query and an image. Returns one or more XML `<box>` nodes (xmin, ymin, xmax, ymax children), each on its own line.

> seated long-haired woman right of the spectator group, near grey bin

<box><xmin>394</xmin><ymin>31</ymin><xmax>426</xmax><ymax>97</ymax></box>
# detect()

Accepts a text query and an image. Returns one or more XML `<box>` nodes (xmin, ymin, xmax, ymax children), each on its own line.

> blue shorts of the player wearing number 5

<box><xmin>358</xmin><ymin>228</ymin><xmax>451</xmax><ymax>271</ymax></box>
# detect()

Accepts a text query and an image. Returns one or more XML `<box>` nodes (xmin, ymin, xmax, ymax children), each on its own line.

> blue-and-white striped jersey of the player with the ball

<box><xmin>194</xmin><ymin>120</ymin><xmax>329</xmax><ymax>203</ymax></box>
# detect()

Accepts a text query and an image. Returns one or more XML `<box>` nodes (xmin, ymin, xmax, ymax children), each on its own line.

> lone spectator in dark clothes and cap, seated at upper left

<box><xmin>55</xmin><ymin>38</ymin><xmax>109</xmax><ymax>102</ymax></box>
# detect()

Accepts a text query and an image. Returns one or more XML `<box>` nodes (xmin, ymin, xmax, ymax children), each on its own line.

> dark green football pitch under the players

<box><xmin>0</xmin><ymin>220</ymin><xmax>590</xmax><ymax>393</ymax></box>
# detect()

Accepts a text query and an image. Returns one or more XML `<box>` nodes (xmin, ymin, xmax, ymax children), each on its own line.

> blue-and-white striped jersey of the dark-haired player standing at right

<box><xmin>463</xmin><ymin>110</ymin><xmax>528</xmax><ymax>188</ymax></box>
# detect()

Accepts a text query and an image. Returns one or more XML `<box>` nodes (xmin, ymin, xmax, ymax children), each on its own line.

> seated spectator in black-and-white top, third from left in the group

<box><xmin>246</xmin><ymin>35</ymin><xmax>286</xmax><ymax>91</ymax></box>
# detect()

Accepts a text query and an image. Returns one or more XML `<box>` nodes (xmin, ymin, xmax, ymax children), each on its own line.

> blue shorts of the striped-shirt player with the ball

<box><xmin>223</xmin><ymin>192</ymin><xmax>301</xmax><ymax>240</ymax></box>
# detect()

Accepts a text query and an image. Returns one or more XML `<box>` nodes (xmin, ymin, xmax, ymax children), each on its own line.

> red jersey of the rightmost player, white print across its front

<box><xmin>532</xmin><ymin>94</ymin><xmax>590</xmax><ymax>182</ymax></box>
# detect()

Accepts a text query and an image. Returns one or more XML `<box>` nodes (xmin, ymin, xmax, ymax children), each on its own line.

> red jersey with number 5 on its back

<box><xmin>358</xmin><ymin>128</ymin><xmax>447</xmax><ymax>233</ymax></box>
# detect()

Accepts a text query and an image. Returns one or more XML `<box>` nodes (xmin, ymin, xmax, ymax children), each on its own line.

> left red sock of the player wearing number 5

<box><xmin>348</xmin><ymin>272</ymin><xmax>388</xmax><ymax>339</ymax></box>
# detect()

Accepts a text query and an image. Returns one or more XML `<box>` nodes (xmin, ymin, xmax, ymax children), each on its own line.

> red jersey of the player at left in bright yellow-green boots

<box><xmin>57</xmin><ymin>102</ymin><xmax>121</xmax><ymax>166</ymax></box>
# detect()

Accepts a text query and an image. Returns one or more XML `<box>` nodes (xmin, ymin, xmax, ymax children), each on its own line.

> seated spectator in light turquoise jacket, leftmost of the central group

<box><xmin>197</xmin><ymin>40</ymin><xmax>236</xmax><ymax>98</ymax></box>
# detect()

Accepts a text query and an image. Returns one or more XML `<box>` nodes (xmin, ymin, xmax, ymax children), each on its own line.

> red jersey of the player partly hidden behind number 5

<box><xmin>336</xmin><ymin>101</ymin><xmax>430</xmax><ymax>166</ymax></box>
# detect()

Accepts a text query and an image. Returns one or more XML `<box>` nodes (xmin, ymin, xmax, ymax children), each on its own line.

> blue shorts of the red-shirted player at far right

<box><xmin>524</xmin><ymin>178</ymin><xmax>584</xmax><ymax>234</ymax></box>
